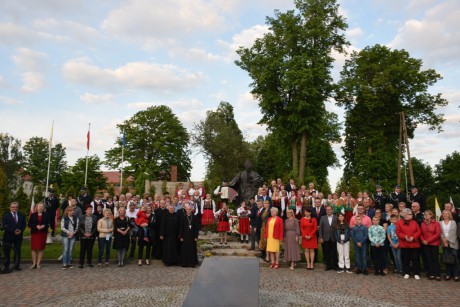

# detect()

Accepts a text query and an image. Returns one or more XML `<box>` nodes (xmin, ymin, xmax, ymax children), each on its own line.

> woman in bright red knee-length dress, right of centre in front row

<box><xmin>300</xmin><ymin>208</ymin><xmax>318</xmax><ymax>270</ymax></box>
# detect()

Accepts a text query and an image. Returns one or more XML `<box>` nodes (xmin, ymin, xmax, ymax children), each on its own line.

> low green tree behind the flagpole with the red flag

<box><xmin>62</xmin><ymin>155</ymin><xmax>107</xmax><ymax>197</ymax></box>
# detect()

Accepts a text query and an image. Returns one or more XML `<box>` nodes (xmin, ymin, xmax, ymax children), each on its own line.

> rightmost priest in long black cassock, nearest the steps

<box><xmin>179</xmin><ymin>205</ymin><xmax>199</xmax><ymax>267</ymax></box>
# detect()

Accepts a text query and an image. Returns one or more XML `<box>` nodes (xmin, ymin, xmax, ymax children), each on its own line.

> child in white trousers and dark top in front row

<box><xmin>335</xmin><ymin>213</ymin><xmax>352</xmax><ymax>273</ymax></box>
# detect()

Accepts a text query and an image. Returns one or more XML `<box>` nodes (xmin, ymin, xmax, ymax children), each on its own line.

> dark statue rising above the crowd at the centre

<box><xmin>228</xmin><ymin>160</ymin><xmax>264</xmax><ymax>206</ymax></box>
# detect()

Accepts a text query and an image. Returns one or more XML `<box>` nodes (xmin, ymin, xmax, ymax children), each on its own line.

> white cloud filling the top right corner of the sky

<box><xmin>388</xmin><ymin>0</ymin><xmax>460</xmax><ymax>64</ymax></box>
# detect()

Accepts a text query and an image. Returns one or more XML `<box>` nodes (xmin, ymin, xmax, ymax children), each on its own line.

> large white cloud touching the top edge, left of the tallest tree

<box><xmin>101</xmin><ymin>0</ymin><xmax>226</xmax><ymax>48</ymax></box>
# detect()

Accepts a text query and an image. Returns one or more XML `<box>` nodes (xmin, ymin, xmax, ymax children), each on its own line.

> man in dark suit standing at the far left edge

<box><xmin>2</xmin><ymin>202</ymin><xmax>26</xmax><ymax>274</ymax></box>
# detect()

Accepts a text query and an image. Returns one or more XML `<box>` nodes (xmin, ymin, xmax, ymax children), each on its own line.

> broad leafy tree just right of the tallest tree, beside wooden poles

<box><xmin>336</xmin><ymin>45</ymin><xmax>447</xmax><ymax>186</ymax></box>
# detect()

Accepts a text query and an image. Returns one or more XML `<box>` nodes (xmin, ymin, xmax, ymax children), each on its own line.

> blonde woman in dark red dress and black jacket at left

<box><xmin>28</xmin><ymin>203</ymin><xmax>50</xmax><ymax>269</ymax></box>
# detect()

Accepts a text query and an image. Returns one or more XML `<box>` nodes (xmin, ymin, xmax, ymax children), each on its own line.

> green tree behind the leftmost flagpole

<box><xmin>23</xmin><ymin>137</ymin><xmax>67</xmax><ymax>197</ymax></box>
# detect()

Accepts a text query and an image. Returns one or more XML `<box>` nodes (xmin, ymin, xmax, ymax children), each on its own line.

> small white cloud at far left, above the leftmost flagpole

<box><xmin>11</xmin><ymin>48</ymin><xmax>47</xmax><ymax>93</ymax></box>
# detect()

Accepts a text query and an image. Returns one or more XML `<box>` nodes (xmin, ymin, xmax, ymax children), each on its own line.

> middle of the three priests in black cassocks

<box><xmin>160</xmin><ymin>205</ymin><xmax>179</xmax><ymax>266</ymax></box>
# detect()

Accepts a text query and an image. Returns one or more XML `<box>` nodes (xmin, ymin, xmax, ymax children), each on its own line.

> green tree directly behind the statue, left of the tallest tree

<box><xmin>192</xmin><ymin>101</ymin><xmax>252</xmax><ymax>184</ymax></box>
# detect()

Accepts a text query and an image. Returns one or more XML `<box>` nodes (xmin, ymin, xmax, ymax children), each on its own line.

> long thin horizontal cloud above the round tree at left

<box><xmin>62</xmin><ymin>58</ymin><xmax>203</xmax><ymax>92</ymax></box>
